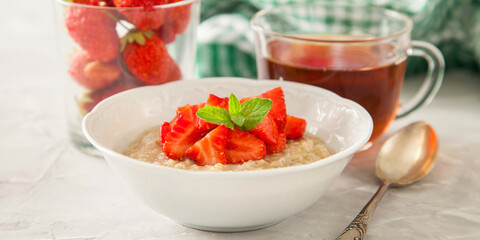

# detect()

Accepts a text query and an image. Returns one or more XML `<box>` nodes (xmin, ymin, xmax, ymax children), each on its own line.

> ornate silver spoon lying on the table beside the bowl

<box><xmin>337</xmin><ymin>122</ymin><xmax>438</xmax><ymax>240</ymax></box>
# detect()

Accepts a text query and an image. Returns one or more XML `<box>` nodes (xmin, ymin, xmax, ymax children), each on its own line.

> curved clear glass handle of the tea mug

<box><xmin>396</xmin><ymin>41</ymin><xmax>445</xmax><ymax>118</ymax></box>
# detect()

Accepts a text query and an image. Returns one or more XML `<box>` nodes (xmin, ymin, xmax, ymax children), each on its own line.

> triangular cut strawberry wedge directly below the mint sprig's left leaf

<box><xmin>186</xmin><ymin>125</ymin><xmax>227</xmax><ymax>166</ymax></box>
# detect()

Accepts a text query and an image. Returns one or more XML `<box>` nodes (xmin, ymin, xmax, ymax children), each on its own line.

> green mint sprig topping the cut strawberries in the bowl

<box><xmin>197</xmin><ymin>93</ymin><xmax>272</xmax><ymax>131</ymax></box>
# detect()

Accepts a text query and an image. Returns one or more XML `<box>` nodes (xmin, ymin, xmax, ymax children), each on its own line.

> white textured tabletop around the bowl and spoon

<box><xmin>0</xmin><ymin>0</ymin><xmax>480</xmax><ymax>240</ymax></box>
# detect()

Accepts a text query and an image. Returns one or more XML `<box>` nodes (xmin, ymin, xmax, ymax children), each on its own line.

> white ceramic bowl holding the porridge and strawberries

<box><xmin>83</xmin><ymin>78</ymin><xmax>373</xmax><ymax>231</ymax></box>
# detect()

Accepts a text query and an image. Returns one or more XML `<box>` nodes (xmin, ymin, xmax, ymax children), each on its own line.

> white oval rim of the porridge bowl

<box><xmin>82</xmin><ymin>77</ymin><xmax>373</xmax><ymax>177</ymax></box>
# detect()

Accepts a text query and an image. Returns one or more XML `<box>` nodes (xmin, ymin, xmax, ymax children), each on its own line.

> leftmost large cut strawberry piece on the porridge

<box><xmin>162</xmin><ymin>105</ymin><xmax>201</xmax><ymax>160</ymax></box>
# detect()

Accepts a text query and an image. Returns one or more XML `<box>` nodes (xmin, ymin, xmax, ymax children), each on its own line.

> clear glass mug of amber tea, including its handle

<box><xmin>251</xmin><ymin>3</ymin><xmax>445</xmax><ymax>143</ymax></box>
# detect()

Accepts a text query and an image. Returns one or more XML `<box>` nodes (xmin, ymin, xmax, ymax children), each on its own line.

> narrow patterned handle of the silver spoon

<box><xmin>336</xmin><ymin>182</ymin><xmax>390</xmax><ymax>240</ymax></box>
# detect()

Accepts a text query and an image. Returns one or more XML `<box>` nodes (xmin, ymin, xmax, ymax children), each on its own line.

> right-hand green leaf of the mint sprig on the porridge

<box><xmin>240</xmin><ymin>97</ymin><xmax>272</xmax><ymax>131</ymax></box>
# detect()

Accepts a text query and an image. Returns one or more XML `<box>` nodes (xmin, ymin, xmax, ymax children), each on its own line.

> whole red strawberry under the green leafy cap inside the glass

<box><xmin>123</xmin><ymin>35</ymin><xmax>170</xmax><ymax>84</ymax></box>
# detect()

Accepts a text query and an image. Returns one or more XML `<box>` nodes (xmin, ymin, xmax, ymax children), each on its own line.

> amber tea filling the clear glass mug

<box><xmin>259</xmin><ymin>39</ymin><xmax>406</xmax><ymax>141</ymax></box>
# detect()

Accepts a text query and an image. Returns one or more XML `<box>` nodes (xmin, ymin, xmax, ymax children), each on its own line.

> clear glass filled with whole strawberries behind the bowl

<box><xmin>55</xmin><ymin>0</ymin><xmax>200</xmax><ymax>155</ymax></box>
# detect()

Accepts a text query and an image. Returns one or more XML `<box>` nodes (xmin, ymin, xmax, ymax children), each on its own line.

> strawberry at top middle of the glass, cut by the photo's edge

<box><xmin>113</xmin><ymin>0</ymin><xmax>165</xmax><ymax>30</ymax></box>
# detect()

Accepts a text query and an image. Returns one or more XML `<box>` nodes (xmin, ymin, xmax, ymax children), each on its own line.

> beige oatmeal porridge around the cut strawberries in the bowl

<box><xmin>123</xmin><ymin>127</ymin><xmax>333</xmax><ymax>171</ymax></box>
